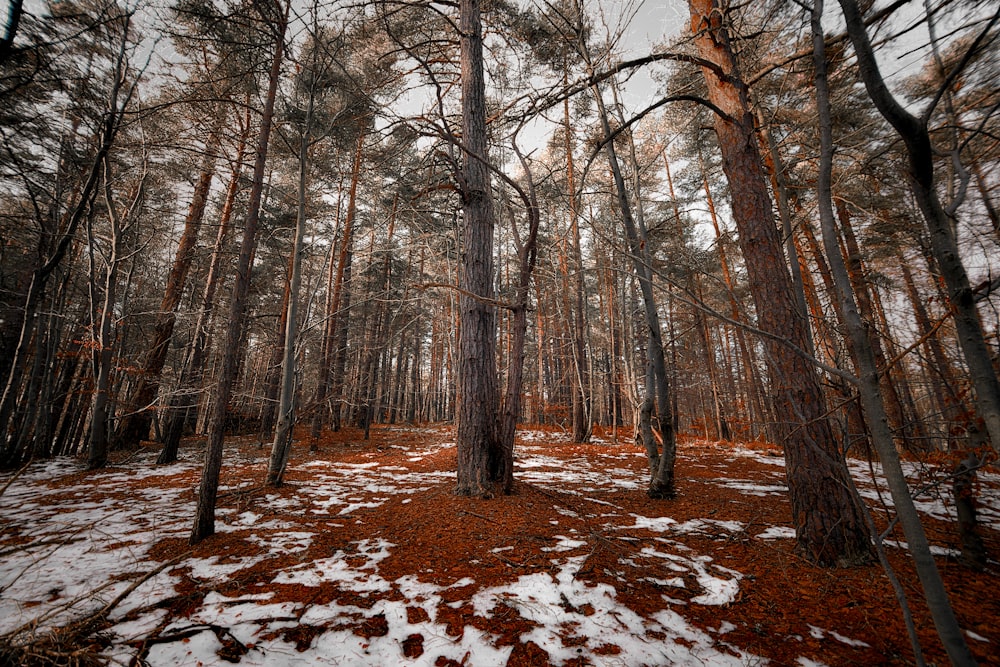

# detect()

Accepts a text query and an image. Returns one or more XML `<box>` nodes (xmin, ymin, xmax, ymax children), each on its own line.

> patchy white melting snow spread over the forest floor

<box><xmin>0</xmin><ymin>431</ymin><xmax>1000</xmax><ymax>667</ymax></box>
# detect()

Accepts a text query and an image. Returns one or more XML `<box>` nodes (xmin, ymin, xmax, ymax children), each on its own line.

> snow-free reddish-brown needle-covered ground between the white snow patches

<box><xmin>95</xmin><ymin>427</ymin><xmax>1000</xmax><ymax>667</ymax></box>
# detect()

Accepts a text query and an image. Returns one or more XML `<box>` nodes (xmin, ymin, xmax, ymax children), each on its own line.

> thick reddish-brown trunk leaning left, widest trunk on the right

<box><xmin>690</xmin><ymin>0</ymin><xmax>871</xmax><ymax>566</ymax></box>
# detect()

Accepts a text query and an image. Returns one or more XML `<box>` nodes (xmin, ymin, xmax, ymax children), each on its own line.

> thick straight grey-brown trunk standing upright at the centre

<box><xmin>456</xmin><ymin>0</ymin><xmax>502</xmax><ymax>497</ymax></box>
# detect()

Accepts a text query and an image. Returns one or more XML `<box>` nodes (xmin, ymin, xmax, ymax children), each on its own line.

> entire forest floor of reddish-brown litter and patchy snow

<box><xmin>0</xmin><ymin>426</ymin><xmax>1000</xmax><ymax>666</ymax></box>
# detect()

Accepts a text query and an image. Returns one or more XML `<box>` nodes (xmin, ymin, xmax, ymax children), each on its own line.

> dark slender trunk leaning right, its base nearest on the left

<box><xmin>190</xmin><ymin>5</ymin><xmax>288</xmax><ymax>544</ymax></box>
